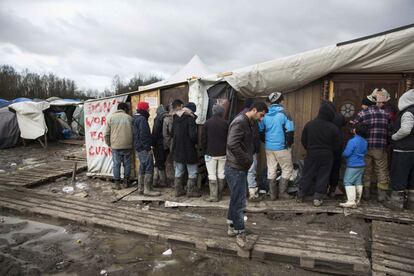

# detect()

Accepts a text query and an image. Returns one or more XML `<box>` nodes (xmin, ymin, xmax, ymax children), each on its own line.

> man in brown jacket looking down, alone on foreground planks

<box><xmin>225</xmin><ymin>102</ymin><xmax>267</xmax><ymax>248</ymax></box>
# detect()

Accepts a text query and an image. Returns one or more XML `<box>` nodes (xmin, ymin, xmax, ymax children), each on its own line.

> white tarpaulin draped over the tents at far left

<box><xmin>9</xmin><ymin>102</ymin><xmax>50</xmax><ymax>139</ymax></box>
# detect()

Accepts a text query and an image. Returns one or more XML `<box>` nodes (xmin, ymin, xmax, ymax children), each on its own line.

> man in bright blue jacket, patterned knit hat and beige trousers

<box><xmin>259</xmin><ymin>92</ymin><xmax>295</xmax><ymax>200</ymax></box>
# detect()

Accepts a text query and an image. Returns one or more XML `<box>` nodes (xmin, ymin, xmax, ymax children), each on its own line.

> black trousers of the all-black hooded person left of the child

<box><xmin>298</xmin><ymin>152</ymin><xmax>333</xmax><ymax>199</ymax></box>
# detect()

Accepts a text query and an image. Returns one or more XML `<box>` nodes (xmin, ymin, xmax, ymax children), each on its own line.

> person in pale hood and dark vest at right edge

<box><xmin>385</xmin><ymin>89</ymin><xmax>414</xmax><ymax>210</ymax></box>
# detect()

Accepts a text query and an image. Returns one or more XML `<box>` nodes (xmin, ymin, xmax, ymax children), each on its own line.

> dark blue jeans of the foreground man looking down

<box><xmin>224</xmin><ymin>164</ymin><xmax>247</xmax><ymax>233</ymax></box>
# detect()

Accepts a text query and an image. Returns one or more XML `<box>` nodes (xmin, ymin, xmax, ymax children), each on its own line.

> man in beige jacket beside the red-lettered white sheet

<box><xmin>105</xmin><ymin>103</ymin><xmax>132</xmax><ymax>190</ymax></box>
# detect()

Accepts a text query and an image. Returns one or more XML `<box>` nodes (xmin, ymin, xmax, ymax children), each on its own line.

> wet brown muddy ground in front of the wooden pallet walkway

<box><xmin>0</xmin><ymin>216</ymin><xmax>321</xmax><ymax>275</ymax></box>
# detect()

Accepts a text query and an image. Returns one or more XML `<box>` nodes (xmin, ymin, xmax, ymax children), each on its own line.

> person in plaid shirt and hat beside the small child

<box><xmin>351</xmin><ymin>90</ymin><xmax>390</xmax><ymax>202</ymax></box>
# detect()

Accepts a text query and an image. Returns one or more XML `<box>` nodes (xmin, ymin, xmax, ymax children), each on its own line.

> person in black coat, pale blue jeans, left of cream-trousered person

<box><xmin>172</xmin><ymin>102</ymin><xmax>201</xmax><ymax>197</ymax></box>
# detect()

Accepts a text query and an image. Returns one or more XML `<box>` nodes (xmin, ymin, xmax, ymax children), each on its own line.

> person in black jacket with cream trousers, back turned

<box><xmin>202</xmin><ymin>104</ymin><xmax>229</xmax><ymax>202</ymax></box>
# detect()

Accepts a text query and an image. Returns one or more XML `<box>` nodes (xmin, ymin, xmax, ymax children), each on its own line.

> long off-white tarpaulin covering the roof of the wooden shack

<box><xmin>224</xmin><ymin>24</ymin><xmax>414</xmax><ymax>97</ymax></box>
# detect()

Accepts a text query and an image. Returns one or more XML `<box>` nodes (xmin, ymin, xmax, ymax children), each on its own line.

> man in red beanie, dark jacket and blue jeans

<box><xmin>133</xmin><ymin>102</ymin><xmax>160</xmax><ymax>196</ymax></box>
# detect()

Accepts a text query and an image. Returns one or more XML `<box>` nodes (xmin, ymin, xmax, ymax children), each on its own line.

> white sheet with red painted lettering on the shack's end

<box><xmin>84</xmin><ymin>96</ymin><xmax>128</xmax><ymax>176</ymax></box>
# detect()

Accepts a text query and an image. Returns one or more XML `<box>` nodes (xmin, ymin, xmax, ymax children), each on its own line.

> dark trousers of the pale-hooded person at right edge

<box><xmin>391</xmin><ymin>151</ymin><xmax>414</xmax><ymax>191</ymax></box>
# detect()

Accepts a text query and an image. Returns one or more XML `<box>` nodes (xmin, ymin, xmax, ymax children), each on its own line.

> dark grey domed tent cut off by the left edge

<box><xmin>0</xmin><ymin>107</ymin><xmax>20</xmax><ymax>149</ymax></box>
